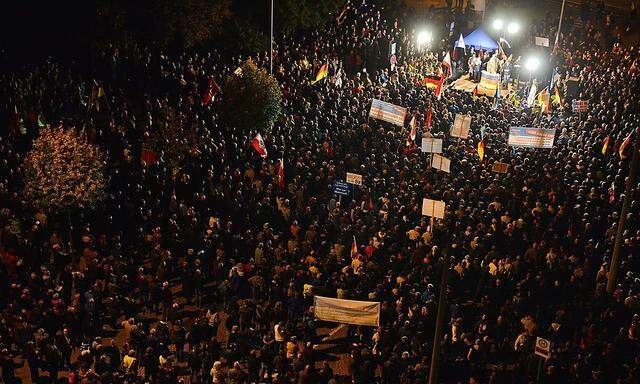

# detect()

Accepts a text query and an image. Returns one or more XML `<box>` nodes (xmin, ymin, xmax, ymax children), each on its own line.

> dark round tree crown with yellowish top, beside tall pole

<box><xmin>222</xmin><ymin>60</ymin><xmax>282</xmax><ymax>133</ymax></box>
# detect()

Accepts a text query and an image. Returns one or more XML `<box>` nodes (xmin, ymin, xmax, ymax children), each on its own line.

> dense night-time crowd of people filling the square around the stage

<box><xmin>0</xmin><ymin>0</ymin><xmax>640</xmax><ymax>384</ymax></box>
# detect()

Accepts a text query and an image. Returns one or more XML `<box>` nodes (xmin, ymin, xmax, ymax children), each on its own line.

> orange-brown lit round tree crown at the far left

<box><xmin>24</xmin><ymin>127</ymin><xmax>107</xmax><ymax>212</ymax></box>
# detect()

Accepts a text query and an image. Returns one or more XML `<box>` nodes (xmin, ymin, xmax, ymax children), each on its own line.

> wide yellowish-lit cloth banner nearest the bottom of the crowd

<box><xmin>313</xmin><ymin>296</ymin><xmax>380</xmax><ymax>327</ymax></box>
